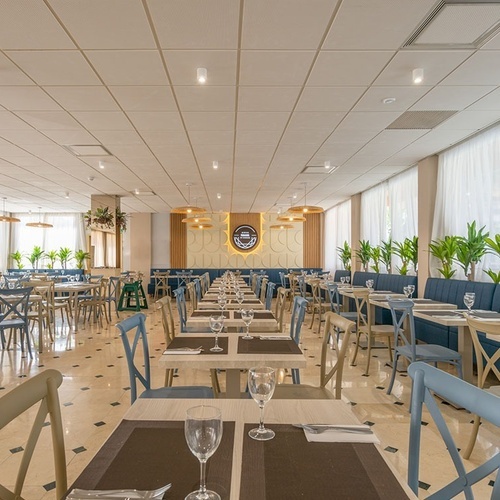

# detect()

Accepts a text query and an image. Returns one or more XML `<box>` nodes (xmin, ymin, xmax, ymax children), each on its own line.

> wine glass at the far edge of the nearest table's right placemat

<box><xmin>248</xmin><ymin>366</ymin><xmax>276</xmax><ymax>441</ymax></box>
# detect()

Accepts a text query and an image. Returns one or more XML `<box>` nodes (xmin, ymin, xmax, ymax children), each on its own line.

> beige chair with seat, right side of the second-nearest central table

<box><xmin>273</xmin><ymin>312</ymin><xmax>356</xmax><ymax>399</ymax></box>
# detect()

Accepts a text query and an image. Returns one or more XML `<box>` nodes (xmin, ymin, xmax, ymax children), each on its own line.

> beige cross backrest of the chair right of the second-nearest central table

<box><xmin>319</xmin><ymin>312</ymin><xmax>356</xmax><ymax>399</ymax></box>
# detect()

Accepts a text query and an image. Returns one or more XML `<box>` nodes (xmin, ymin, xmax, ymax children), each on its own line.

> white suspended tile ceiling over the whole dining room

<box><xmin>0</xmin><ymin>0</ymin><xmax>500</xmax><ymax>212</ymax></box>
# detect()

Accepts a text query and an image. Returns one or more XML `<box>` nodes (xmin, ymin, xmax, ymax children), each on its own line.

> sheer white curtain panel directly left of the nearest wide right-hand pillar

<box><xmin>388</xmin><ymin>167</ymin><xmax>418</xmax><ymax>269</ymax></box>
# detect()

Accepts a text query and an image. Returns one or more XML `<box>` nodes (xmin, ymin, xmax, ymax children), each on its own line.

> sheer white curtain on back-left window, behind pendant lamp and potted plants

<box><xmin>10</xmin><ymin>213</ymin><xmax>86</xmax><ymax>267</ymax></box>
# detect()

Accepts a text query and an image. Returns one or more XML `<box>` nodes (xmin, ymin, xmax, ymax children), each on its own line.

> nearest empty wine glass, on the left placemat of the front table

<box><xmin>184</xmin><ymin>405</ymin><xmax>222</xmax><ymax>500</ymax></box>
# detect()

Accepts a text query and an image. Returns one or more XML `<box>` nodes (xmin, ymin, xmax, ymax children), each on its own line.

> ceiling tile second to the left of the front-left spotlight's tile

<box><xmin>7</xmin><ymin>50</ymin><xmax>101</xmax><ymax>85</ymax></box>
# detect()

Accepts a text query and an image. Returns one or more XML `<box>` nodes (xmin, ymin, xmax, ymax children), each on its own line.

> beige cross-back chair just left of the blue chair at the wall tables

<box><xmin>351</xmin><ymin>289</ymin><xmax>394</xmax><ymax>375</ymax></box>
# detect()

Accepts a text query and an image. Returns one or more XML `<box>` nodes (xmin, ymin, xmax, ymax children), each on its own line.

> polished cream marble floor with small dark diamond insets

<box><xmin>0</xmin><ymin>298</ymin><xmax>500</xmax><ymax>500</ymax></box>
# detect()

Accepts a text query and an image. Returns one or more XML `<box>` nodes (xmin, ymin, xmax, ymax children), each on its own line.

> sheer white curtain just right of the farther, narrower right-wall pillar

<box><xmin>361</xmin><ymin>182</ymin><xmax>390</xmax><ymax>246</ymax></box>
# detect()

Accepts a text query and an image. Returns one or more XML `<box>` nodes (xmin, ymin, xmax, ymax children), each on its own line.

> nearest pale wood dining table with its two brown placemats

<box><xmin>70</xmin><ymin>398</ymin><xmax>417</xmax><ymax>500</ymax></box>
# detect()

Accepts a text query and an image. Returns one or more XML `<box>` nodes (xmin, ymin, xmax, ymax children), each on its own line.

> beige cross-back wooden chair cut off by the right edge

<box><xmin>463</xmin><ymin>316</ymin><xmax>500</xmax><ymax>459</ymax></box>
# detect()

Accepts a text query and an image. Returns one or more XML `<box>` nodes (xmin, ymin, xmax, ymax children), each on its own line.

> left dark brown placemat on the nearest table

<box><xmin>70</xmin><ymin>420</ymin><xmax>234</xmax><ymax>500</ymax></box>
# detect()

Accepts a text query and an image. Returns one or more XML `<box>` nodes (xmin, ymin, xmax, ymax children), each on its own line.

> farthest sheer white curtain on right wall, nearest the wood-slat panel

<box><xmin>325</xmin><ymin>200</ymin><xmax>351</xmax><ymax>273</ymax></box>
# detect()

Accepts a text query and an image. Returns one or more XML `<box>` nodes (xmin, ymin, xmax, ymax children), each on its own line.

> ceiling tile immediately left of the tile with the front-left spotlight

<box><xmin>85</xmin><ymin>50</ymin><xmax>168</xmax><ymax>85</ymax></box>
